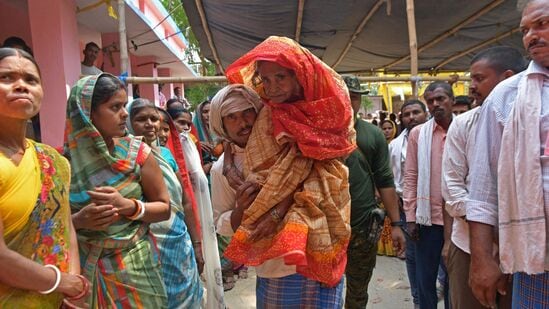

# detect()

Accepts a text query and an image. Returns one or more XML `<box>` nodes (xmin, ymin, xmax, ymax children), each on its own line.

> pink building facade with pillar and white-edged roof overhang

<box><xmin>0</xmin><ymin>0</ymin><xmax>196</xmax><ymax>146</ymax></box>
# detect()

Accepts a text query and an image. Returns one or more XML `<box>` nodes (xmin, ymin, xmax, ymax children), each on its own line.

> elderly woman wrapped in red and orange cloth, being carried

<box><xmin>225</xmin><ymin>37</ymin><xmax>356</xmax><ymax>307</ymax></box>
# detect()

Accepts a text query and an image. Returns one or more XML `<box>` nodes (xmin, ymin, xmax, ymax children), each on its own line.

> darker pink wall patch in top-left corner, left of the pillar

<box><xmin>0</xmin><ymin>0</ymin><xmax>32</xmax><ymax>48</ymax></box>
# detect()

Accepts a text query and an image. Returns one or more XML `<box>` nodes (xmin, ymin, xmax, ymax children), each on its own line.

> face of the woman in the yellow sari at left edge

<box><xmin>0</xmin><ymin>56</ymin><xmax>44</xmax><ymax>120</ymax></box>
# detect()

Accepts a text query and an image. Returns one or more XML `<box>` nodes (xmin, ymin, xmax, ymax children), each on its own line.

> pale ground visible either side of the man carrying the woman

<box><xmin>225</xmin><ymin>256</ymin><xmax>444</xmax><ymax>309</ymax></box>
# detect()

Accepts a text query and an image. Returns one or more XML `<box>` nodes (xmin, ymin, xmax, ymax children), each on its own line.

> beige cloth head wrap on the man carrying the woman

<box><xmin>210</xmin><ymin>84</ymin><xmax>263</xmax><ymax>141</ymax></box>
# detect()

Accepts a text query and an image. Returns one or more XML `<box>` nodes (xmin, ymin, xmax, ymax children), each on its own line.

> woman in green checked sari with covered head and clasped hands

<box><xmin>65</xmin><ymin>74</ymin><xmax>170</xmax><ymax>309</ymax></box>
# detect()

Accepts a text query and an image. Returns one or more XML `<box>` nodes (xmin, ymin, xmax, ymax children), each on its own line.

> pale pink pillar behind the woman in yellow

<box><xmin>28</xmin><ymin>0</ymin><xmax>81</xmax><ymax>146</ymax></box>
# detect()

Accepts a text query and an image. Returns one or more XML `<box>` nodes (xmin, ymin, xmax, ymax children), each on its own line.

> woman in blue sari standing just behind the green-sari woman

<box><xmin>127</xmin><ymin>99</ymin><xmax>204</xmax><ymax>308</ymax></box>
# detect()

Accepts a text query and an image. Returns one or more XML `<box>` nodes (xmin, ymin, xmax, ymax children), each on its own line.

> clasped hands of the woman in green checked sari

<box><xmin>72</xmin><ymin>203</ymin><xmax>119</xmax><ymax>231</ymax></box>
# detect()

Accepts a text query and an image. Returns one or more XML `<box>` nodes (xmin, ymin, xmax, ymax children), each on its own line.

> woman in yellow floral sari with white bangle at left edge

<box><xmin>0</xmin><ymin>48</ymin><xmax>89</xmax><ymax>308</ymax></box>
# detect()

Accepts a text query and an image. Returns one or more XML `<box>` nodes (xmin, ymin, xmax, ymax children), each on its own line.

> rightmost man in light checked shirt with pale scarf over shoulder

<box><xmin>465</xmin><ymin>0</ymin><xmax>549</xmax><ymax>308</ymax></box>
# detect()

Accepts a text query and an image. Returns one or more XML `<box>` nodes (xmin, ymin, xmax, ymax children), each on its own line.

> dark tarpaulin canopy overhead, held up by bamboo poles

<box><xmin>182</xmin><ymin>0</ymin><xmax>525</xmax><ymax>73</ymax></box>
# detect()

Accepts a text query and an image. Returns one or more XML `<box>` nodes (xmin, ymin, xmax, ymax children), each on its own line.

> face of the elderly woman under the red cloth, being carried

<box><xmin>257</xmin><ymin>61</ymin><xmax>303</xmax><ymax>103</ymax></box>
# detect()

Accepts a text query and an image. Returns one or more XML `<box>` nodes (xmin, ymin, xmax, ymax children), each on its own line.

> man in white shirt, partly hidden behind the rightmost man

<box><xmin>442</xmin><ymin>46</ymin><xmax>526</xmax><ymax>309</ymax></box>
